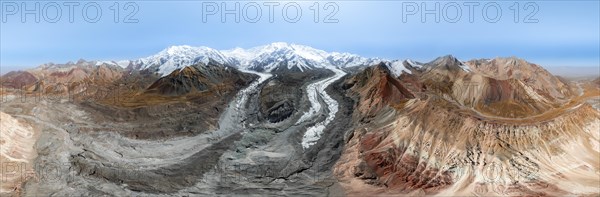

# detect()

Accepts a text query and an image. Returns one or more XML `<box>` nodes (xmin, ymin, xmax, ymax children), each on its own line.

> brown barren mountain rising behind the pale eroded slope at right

<box><xmin>405</xmin><ymin>56</ymin><xmax>572</xmax><ymax>118</ymax></box>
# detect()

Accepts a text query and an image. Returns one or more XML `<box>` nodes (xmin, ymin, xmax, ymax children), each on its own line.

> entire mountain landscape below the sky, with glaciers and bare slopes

<box><xmin>0</xmin><ymin>43</ymin><xmax>600</xmax><ymax>196</ymax></box>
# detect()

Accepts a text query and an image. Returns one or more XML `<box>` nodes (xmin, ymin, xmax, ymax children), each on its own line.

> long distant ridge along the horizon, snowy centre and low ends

<box><xmin>5</xmin><ymin>42</ymin><xmax>584</xmax><ymax>80</ymax></box>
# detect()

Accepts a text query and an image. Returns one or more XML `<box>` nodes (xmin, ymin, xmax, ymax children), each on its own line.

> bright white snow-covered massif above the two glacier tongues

<box><xmin>134</xmin><ymin>42</ymin><xmax>384</xmax><ymax>76</ymax></box>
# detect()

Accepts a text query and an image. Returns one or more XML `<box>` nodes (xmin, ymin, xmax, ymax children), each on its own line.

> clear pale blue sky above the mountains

<box><xmin>0</xmin><ymin>0</ymin><xmax>600</xmax><ymax>73</ymax></box>
